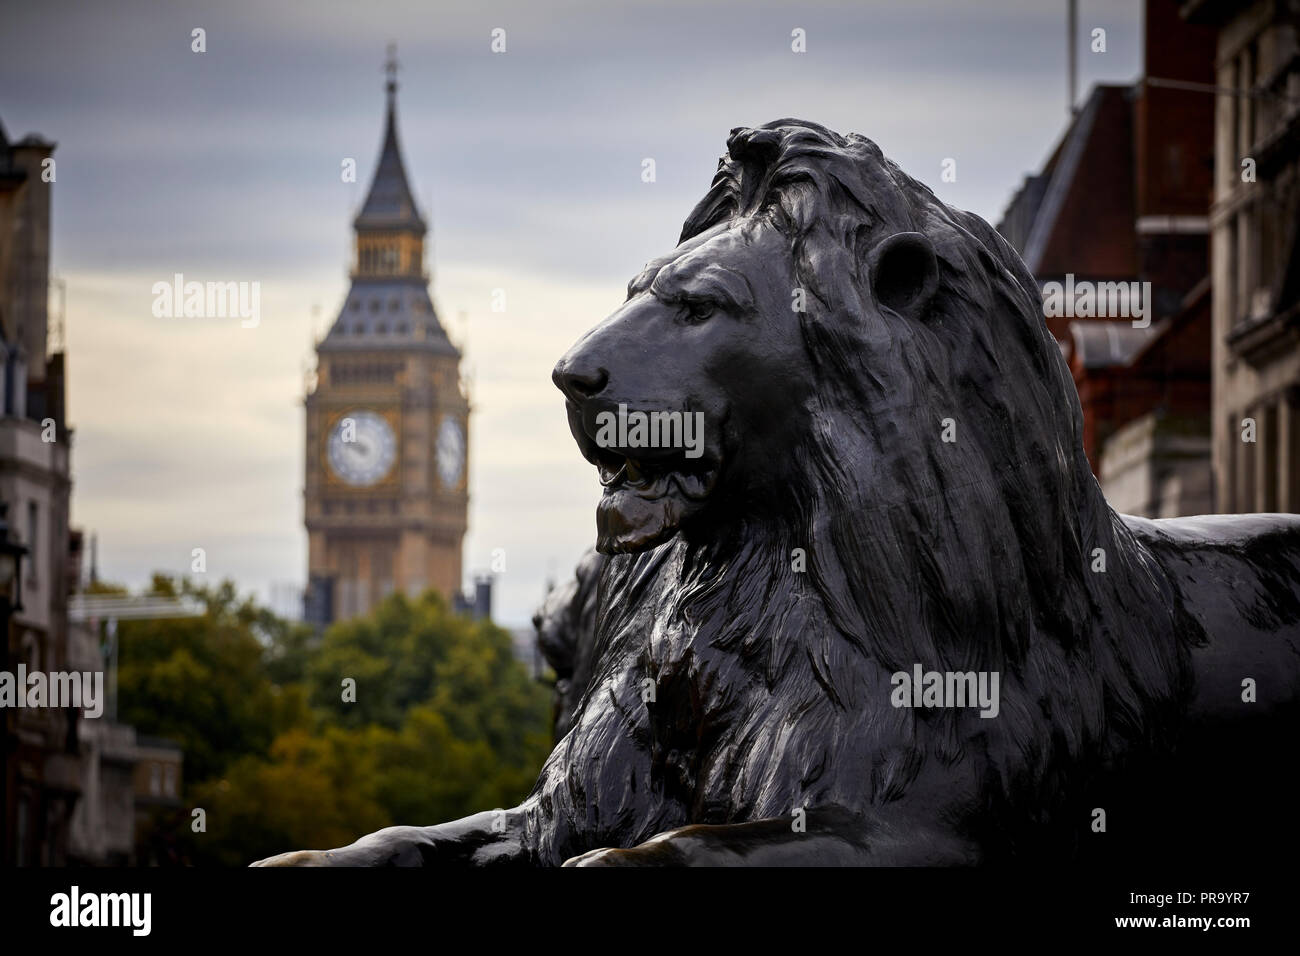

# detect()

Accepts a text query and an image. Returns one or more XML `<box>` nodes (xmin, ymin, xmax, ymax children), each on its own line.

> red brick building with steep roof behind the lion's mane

<box><xmin>998</xmin><ymin>0</ymin><xmax>1214</xmax><ymax>515</ymax></box>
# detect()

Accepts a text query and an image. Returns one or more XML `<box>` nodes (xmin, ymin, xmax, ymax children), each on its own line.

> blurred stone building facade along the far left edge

<box><xmin>0</xmin><ymin>115</ymin><xmax>81</xmax><ymax>865</ymax></box>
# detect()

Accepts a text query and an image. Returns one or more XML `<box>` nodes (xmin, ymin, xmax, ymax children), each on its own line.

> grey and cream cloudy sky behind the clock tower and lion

<box><xmin>0</xmin><ymin>0</ymin><xmax>1141</xmax><ymax>626</ymax></box>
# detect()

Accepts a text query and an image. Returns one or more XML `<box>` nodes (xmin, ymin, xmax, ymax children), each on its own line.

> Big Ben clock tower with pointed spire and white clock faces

<box><xmin>304</xmin><ymin>50</ymin><xmax>469</xmax><ymax>623</ymax></box>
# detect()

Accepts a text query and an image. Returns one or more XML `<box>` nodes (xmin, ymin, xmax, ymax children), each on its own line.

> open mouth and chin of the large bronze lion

<box><xmin>569</xmin><ymin>405</ymin><xmax>722</xmax><ymax>554</ymax></box>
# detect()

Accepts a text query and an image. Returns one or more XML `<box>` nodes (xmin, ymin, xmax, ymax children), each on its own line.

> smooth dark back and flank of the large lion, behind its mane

<box><xmin>1086</xmin><ymin>514</ymin><xmax>1300</xmax><ymax>865</ymax></box>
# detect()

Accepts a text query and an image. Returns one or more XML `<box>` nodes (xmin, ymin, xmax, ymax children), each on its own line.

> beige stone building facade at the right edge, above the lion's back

<box><xmin>1183</xmin><ymin>0</ymin><xmax>1300</xmax><ymax>512</ymax></box>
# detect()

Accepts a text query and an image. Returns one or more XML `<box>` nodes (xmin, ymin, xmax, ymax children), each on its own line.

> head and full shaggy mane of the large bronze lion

<box><xmin>554</xmin><ymin>120</ymin><xmax>1182</xmax><ymax>816</ymax></box>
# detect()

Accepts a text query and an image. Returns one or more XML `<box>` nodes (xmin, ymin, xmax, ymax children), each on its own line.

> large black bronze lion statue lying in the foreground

<box><xmin>263</xmin><ymin>120</ymin><xmax>1300</xmax><ymax>865</ymax></box>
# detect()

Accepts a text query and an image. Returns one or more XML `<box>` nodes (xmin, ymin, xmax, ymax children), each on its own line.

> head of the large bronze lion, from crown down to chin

<box><xmin>554</xmin><ymin>120</ymin><xmax>1086</xmax><ymax>582</ymax></box>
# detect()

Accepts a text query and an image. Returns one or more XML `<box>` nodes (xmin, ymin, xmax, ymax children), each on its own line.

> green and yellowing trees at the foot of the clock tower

<box><xmin>120</xmin><ymin>578</ymin><xmax>550</xmax><ymax>865</ymax></box>
